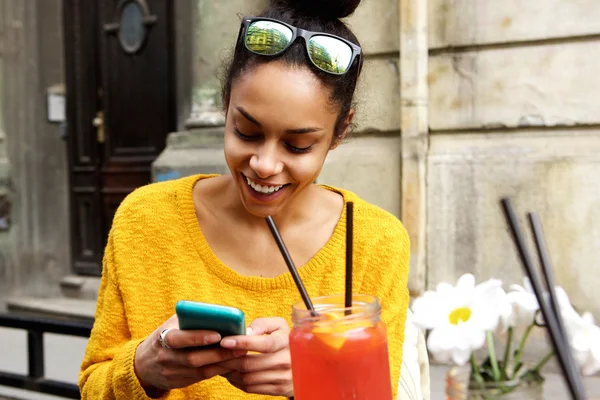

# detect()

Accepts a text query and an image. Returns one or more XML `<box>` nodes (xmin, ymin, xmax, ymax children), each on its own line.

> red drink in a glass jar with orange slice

<box><xmin>290</xmin><ymin>295</ymin><xmax>392</xmax><ymax>400</ymax></box>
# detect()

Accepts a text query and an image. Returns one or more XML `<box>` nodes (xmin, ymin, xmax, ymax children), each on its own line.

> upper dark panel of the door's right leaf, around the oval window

<box><xmin>102</xmin><ymin>0</ymin><xmax>174</xmax><ymax>159</ymax></box>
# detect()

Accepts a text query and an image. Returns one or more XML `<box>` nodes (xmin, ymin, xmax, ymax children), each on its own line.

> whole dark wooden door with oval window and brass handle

<box><xmin>64</xmin><ymin>0</ymin><xmax>176</xmax><ymax>275</ymax></box>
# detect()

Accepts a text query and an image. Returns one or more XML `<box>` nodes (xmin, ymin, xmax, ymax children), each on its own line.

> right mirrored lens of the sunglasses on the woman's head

<box><xmin>308</xmin><ymin>35</ymin><xmax>352</xmax><ymax>74</ymax></box>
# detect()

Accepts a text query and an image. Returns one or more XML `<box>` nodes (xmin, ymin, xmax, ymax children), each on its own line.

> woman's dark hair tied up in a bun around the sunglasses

<box><xmin>223</xmin><ymin>0</ymin><xmax>363</xmax><ymax>136</ymax></box>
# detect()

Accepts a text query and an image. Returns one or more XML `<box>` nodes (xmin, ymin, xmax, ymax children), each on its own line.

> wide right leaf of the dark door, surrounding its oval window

<box><xmin>101</xmin><ymin>0</ymin><xmax>175</xmax><ymax>244</ymax></box>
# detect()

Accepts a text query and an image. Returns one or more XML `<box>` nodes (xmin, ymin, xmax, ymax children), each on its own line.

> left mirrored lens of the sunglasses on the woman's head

<box><xmin>246</xmin><ymin>21</ymin><xmax>293</xmax><ymax>55</ymax></box>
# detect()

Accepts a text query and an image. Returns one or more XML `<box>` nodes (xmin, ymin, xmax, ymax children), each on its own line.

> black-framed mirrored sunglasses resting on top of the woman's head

<box><xmin>240</xmin><ymin>17</ymin><xmax>361</xmax><ymax>75</ymax></box>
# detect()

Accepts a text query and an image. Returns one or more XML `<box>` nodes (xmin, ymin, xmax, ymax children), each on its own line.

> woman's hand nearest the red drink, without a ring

<box><xmin>218</xmin><ymin>318</ymin><xmax>294</xmax><ymax>397</ymax></box>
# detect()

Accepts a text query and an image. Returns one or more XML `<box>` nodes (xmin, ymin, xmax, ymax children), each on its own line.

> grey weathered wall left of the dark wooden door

<box><xmin>0</xmin><ymin>0</ymin><xmax>69</xmax><ymax>302</ymax></box>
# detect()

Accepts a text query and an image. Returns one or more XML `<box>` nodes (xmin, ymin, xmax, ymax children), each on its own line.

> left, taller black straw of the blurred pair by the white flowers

<box><xmin>501</xmin><ymin>198</ymin><xmax>585</xmax><ymax>400</ymax></box>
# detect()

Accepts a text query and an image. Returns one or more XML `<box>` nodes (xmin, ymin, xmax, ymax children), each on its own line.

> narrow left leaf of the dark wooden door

<box><xmin>63</xmin><ymin>0</ymin><xmax>103</xmax><ymax>274</ymax></box>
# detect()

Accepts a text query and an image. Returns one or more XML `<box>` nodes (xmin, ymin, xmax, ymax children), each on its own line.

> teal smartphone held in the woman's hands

<box><xmin>175</xmin><ymin>300</ymin><xmax>246</xmax><ymax>337</ymax></box>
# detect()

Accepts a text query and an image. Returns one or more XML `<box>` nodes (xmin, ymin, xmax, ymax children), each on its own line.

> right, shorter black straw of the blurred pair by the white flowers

<box><xmin>527</xmin><ymin>212</ymin><xmax>585</xmax><ymax>393</ymax></box>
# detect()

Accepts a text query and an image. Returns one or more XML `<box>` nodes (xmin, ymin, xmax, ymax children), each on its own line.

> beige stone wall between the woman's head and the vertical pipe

<box><xmin>319</xmin><ymin>0</ymin><xmax>401</xmax><ymax>217</ymax></box>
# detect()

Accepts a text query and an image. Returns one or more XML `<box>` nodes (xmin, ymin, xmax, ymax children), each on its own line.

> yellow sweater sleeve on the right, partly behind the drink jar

<box><xmin>361</xmin><ymin>221</ymin><xmax>410</xmax><ymax>396</ymax></box>
